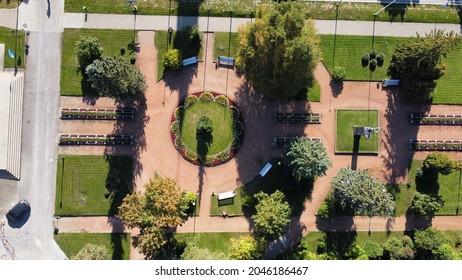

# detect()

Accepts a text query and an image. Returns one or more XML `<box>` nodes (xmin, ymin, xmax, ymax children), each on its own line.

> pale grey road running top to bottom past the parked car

<box><xmin>2</xmin><ymin>0</ymin><xmax>66</xmax><ymax>260</ymax></box>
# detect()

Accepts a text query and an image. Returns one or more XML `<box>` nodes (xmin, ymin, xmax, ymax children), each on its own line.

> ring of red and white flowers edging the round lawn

<box><xmin>170</xmin><ymin>91</ymin><xmax>244</xmax><ymax>167</ymax></box>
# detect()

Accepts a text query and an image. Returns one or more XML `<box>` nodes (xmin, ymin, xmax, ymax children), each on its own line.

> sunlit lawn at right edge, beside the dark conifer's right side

<box><xmin>433</xmin><ymin>45</ymin><xmax>462</xmax><ymax>105</ymax></box>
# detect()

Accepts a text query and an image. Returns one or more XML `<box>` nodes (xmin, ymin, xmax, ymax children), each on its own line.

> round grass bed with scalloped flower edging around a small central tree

<box><xmin>170</xmin><ymin>91</ymin><xmax>244</xmax><ymax>166</ymax></box>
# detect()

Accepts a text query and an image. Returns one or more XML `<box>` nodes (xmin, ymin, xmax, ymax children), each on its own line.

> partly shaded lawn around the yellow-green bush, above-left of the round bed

<box><xmin>154</xmin><ymin>30</ymin><xmax>203</xmax><ymax>80</ymax></box>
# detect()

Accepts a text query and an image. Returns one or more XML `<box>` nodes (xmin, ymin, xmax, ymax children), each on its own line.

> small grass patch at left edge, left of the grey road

<box><xmin>0</xmin><ymin>26</ymin><xmax>25</xmax><ymax>68</ymax></box>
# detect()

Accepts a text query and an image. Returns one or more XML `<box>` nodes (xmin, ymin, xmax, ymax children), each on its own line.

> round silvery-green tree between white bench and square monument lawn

<box><xmin>283</xmin><ymin>137</ymin><xmax>332</xmax><ymax>180</ymax></box>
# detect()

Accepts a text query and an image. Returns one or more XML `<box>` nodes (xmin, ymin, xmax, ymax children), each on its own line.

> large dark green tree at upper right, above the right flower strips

<box><xmin>388</xmin><ymin>30</ymin><xmax>461</xmax><ymax>102</ymax></box>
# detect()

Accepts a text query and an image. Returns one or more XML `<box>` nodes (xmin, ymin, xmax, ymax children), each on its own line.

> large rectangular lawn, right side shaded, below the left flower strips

<box><xmin>55</xmin><ymin>155</ymin><xmax>132</xmax><ymax>216</ymax></box>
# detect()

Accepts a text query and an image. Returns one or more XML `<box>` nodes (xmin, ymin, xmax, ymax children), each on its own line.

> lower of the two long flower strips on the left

<box><xmin>59</xmin><ymin>134</ymin><xmax>133</xmax><ymax>146</ymax></box>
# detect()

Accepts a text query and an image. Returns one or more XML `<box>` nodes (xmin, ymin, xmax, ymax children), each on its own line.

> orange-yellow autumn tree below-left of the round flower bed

<box><xmin>118</xmin><ymin>177</ymin><xmax>185</xmax><ymax>259</ymax></box>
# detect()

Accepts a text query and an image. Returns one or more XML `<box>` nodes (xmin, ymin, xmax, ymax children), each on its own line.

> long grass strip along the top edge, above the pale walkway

<box><xmin>65</xmin><ymin>0</ymin><xmax>460</xmax><ymax>23</ymax></box>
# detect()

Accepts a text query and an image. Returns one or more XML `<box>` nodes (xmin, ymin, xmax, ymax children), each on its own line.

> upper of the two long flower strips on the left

<box><xmin>61</xmin><ymin>108</ymin><xmax>135</xmax><ymax>120</ymax></box>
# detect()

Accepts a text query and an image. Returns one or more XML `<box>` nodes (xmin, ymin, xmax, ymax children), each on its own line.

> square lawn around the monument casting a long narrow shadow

<box><xmin>335</xmin><ymin>110</ymin><xmax>380</xmax><ymax>153</ymax></box>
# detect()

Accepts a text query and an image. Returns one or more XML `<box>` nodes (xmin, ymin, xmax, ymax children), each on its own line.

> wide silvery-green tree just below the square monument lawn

<box><xmin>331</xmin><ymin>168</ymin><xmax>395</xmax><ymax>217</ymax></box>
